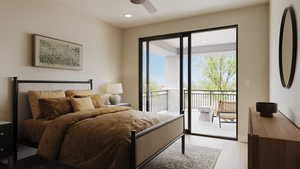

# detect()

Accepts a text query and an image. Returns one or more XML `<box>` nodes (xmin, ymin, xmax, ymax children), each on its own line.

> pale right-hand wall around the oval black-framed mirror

<box><xmin>270</xmin><ymin>0</ymin><xmax>300</xmax><ymax>126</ymax></box>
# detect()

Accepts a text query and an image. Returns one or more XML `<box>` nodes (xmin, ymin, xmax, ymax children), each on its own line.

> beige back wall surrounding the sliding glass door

<box><xmin>122</xmin><ymin>4</ymin><xmax>269</xmax><ymax>141</ymax></box>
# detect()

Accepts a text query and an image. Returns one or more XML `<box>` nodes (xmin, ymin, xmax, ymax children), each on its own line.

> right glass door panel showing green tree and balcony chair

<box><xmin>190</xmin><ymin>28</ymin><xmax>237</xmax><ymax>138</ymax></box>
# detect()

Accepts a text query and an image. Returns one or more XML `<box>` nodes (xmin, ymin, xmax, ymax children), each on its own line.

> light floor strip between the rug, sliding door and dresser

<box><xmin>186</xmin><ymin>135</ymin><xmax>248</xmax><ymax>169</ymax></box>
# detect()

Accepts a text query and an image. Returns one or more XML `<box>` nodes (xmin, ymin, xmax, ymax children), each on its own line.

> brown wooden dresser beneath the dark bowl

<box><xmin>248</xmin><ymin>109</ymin><xmax>300</xmax><ymax>169</ymax></box>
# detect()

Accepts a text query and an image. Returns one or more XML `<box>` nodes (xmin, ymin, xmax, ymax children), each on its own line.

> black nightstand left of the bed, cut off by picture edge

<box><xmin>0</xmin><ymin>121</ymin><xmax>13</xmax><ymax>168</ymax></box>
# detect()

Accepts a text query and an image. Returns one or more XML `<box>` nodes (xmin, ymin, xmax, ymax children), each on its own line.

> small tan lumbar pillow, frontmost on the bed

<box><xmin>71</xmin><ymin>97</ymin><xmax>95</xmax><ymax>111</ymax></box>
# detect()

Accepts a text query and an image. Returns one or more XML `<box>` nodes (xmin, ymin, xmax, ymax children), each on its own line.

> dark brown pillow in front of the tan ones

<box><xmin>39</xmin><ymin>98</ymin><xmax>73</xmax><ymax>120</ymax></box>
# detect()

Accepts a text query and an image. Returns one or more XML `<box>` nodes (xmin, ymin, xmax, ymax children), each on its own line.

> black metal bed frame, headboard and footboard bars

<box><xmin>12</xmin><ymin>77</ymin><xmax>185</xmax><ymax>169</ymax></box>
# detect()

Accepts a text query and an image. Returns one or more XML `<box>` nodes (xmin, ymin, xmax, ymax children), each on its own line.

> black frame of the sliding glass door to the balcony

<box><xmin>138</xmin><ymin>24</ymin><xmax>239</xmax><ymax>140</ymax></box>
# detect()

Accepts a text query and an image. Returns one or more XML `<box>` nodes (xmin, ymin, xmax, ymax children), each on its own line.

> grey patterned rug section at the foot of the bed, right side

<box><xmin>143</xmin><ymin>141</ymin><xmax>221</xmax><ymax>169</ymax></box>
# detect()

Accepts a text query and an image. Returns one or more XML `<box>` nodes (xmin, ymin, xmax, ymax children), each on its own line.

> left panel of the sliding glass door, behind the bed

<box><xmin>140</xmin><ymin>36</ymin><xmax>183</xmax><ymax>114</ymax></box>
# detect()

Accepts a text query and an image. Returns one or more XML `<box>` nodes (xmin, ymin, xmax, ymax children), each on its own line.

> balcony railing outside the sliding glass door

<box><xmin>143</xmin><ymin>90</ymin><xmax>236</xmax><ymax>112</ymax></box>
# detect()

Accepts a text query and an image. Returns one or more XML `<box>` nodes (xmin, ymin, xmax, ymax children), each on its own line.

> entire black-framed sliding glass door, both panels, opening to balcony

<box><xmin>139</xmin><ymin>25</ymin><xmax>238</xmax><ymax>139</ymax></box>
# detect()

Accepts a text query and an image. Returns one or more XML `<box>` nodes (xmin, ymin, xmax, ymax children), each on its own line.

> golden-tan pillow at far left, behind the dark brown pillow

<box><xmin>27</xmin><ymin>90</ymin><xmax>66</xmax><ymax>119</ymax></box>
